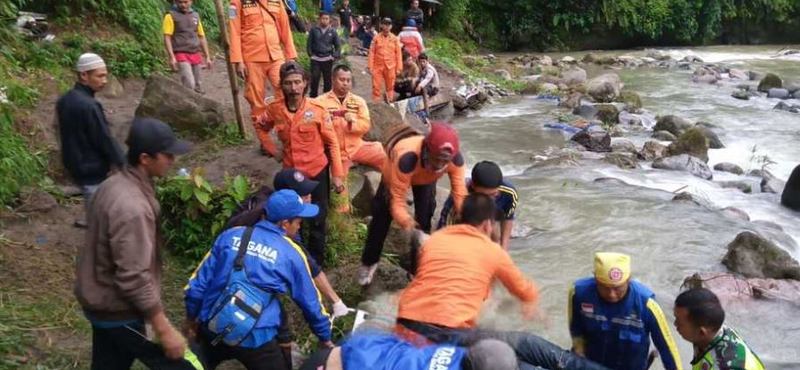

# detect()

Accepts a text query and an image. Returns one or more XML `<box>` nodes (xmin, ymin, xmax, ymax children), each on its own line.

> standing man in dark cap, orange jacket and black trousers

<box><xmin>256</xmin><ymin>61</ymin><xmax>344</xmax><ymax>266</ymax></box>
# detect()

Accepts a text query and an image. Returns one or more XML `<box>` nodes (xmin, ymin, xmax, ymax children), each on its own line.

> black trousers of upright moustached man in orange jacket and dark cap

<box><xmin>304</xmin><ymin>165</ymin><xmax>331</xmax><ymax>268</ymax></box>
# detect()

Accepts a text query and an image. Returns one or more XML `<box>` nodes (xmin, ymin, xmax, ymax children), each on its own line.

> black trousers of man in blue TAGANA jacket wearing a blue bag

<box><xmin>199</xmin><ymin>330</ymin><xmax>286</xmax><ymax>370</ymax></box>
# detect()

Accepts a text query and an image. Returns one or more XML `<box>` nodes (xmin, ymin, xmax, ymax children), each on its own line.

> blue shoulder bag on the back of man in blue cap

<box><xmin>208</xmin><ymin>227</ymin><xmax>273</xmax><ymax>347</ymax></box>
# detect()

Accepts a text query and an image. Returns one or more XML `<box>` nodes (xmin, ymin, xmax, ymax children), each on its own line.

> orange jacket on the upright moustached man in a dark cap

<box><xmin>260</xmin><ymin>98</ymin><xmax>344</xmax><ymax>177</ymax></box>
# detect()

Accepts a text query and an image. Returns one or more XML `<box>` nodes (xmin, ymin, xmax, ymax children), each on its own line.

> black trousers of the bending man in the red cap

<box><xmin>361</xmin><ymin>181</ymin><xmax>436</xmax><ymax>269</ymax></box>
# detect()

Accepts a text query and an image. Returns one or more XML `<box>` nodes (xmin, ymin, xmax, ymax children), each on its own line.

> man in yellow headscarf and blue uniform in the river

<box><xmin>568</xmin><ymin>253</ymin><xmax>682</xmax><ymax>370</ymax></box>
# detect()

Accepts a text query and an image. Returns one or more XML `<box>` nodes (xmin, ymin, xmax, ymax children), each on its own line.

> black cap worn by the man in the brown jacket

<box><xmin>125</xmin><ymin>118</ymin><xmax>192</xmax><ymax>154</ymax></box>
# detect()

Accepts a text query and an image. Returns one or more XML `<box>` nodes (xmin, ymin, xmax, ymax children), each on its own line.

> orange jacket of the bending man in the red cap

<box><xmin>383</xmin><ymin>136</ymin><xmax>467</xmax><ymax>228</ymax></box>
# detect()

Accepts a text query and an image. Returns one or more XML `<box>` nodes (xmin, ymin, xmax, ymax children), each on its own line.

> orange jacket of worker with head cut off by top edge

<box><xmin>228</xmin><ymin>0</ymin><xmax>297</xmax><ymax>63</ymax></box>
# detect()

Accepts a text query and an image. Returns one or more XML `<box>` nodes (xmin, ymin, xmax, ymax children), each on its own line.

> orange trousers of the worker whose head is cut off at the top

<box><xmin>244</xmin><ymin>60</ymin><xmax>284</xmax><ymax>147</ymax></box>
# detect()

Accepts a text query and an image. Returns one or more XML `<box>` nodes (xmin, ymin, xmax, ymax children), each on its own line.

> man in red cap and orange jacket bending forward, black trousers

<box><xmin>357</xmin><ymin>122</ymin><xmax>467</xmax><ymax>285</ymax></box>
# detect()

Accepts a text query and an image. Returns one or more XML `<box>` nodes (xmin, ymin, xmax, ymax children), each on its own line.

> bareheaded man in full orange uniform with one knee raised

<box><xmin>317</xmin><ymin>64</ymin><xmax>386</xmax><ymax>212</ymax></box>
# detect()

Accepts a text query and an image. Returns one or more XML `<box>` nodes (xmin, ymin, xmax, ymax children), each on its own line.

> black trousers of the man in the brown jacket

<box><xmin>92</xmin><ymin>322</ymin><xmax>194</xmax><ymax>370</ymax></box>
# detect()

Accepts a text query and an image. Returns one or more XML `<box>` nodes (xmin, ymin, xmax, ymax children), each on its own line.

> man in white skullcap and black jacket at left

<box><xmin>56</xmin><ymin>53</ymin><xmax>125</xmax><ymax>228</ymax></box>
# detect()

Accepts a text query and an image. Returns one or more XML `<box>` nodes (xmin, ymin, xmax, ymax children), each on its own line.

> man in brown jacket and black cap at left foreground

<box><xmin>75</xmin><ymin>118</ymin><xmax>202</xmax><ymax>370</ymax></box>
